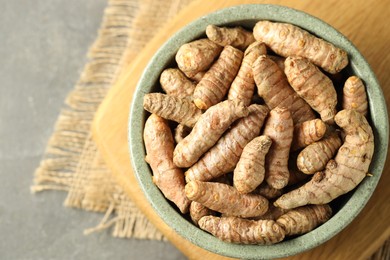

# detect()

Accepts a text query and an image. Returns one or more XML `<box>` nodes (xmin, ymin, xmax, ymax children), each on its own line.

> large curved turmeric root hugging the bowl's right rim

<box><xmin>274</xmin><ymin>110</ymin><xmax>374</xmax><ymax>209</ymax></box>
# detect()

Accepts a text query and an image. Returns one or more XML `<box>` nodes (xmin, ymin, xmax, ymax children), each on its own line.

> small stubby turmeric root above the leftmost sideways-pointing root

<box><xmin>160</xmin><ymin>69</ymin><xmax>196</xmax><ymax>98</ymax></box>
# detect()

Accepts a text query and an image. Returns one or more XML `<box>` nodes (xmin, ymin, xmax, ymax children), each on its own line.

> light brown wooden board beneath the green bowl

<box><xmin>93</xmin><ymin>0</ymin><xmax>390</xmax><ymax>259</ymax></box>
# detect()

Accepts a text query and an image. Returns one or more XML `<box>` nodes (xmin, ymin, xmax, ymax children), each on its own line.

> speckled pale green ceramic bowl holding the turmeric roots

<box><xmin>128</xmin><ymin>4</ymin><xmax>389</xmax><ymax>259</ymax></box>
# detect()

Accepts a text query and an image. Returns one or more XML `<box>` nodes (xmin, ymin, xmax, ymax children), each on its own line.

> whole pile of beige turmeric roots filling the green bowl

<box><xmin>144</xmin><ymin>21</ymin><xmax>374</xmax><ymax>244</ymax></box>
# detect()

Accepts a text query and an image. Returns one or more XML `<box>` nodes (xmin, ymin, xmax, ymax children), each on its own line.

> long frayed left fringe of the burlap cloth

<box><xmin>31</xmin><ymin>0</ymin><xmax>138</xmax><ymax>192</ymax></box>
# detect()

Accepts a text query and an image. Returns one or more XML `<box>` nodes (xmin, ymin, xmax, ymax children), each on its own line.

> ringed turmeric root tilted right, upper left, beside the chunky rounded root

<box><xmin>194</xmin><ymin>46</ymin><xmax>244</xmax><ymax>109</ymax></box>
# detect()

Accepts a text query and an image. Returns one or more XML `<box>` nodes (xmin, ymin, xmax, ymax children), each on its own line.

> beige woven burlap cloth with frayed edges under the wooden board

<box><xmin>31</xmin><ymin>0</ymin><xmax>390</xmax><ymax>259</ymax></box>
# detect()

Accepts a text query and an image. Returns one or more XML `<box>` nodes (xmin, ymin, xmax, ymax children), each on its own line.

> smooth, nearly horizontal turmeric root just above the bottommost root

<box><xmin>185</xmin><ymin>181</ymin><xmax>268</xmax><ymax>218</ymax></box>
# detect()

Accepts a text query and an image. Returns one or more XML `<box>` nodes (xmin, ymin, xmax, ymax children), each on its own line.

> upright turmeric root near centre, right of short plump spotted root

<box><xmin>263</xmin><ymin>107</ymin><xmax>294</xmax><ymax>189</ymax></box>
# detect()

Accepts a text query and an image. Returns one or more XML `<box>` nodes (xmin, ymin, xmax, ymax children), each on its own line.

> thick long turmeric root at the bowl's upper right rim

<box><xmin>253</xmin><ymin>21</ymin><xmax>348</xmax><ymax>74</ymax></box>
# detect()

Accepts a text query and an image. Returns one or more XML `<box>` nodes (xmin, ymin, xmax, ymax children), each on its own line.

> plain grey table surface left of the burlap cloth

<box><xmin>0</xmin><ymin>0</ymin><xmax>185</xmax><ymax>259</ymax></box>
